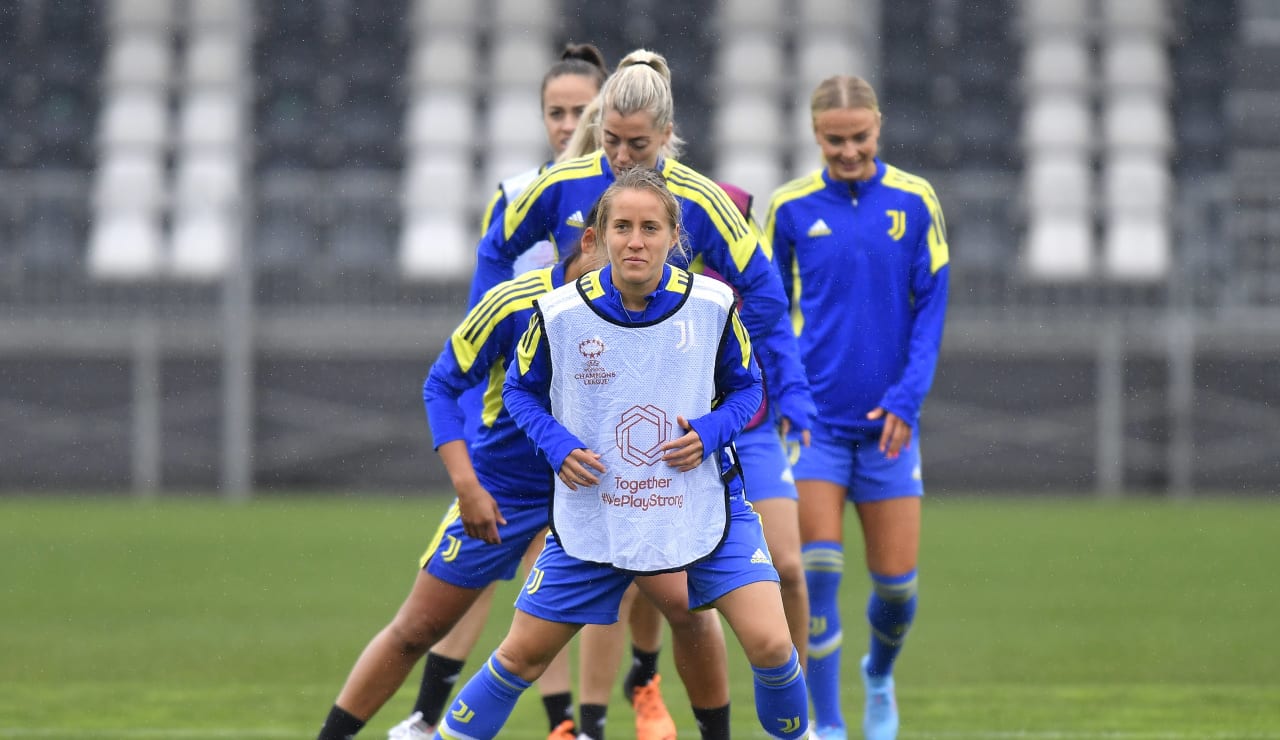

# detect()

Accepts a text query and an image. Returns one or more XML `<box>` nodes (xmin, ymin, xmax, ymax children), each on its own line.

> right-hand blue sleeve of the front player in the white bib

<box><xmin>689</xmin><ymin>304</ymin><xmax>764</xmax><ymax>458</ymax></box>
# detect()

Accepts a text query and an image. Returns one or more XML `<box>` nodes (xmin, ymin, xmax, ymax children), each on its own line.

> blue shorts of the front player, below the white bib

<box><xmin>516</xmin><ymin>497</ymin><xmax>778</xmax><ymax>625</ymax></box>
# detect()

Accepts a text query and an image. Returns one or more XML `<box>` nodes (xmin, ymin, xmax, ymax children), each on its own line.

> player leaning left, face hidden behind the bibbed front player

<box><xmin>311</xmin><ymin>202</ymin><xmax>603</xmax><ymax>740</ymax></box>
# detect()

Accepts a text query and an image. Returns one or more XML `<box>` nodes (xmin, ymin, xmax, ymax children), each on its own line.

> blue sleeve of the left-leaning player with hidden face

<box><xmin>422</xmin><ymin>303</ymin><xmax>515</xmax><ymax>449</ymax></box>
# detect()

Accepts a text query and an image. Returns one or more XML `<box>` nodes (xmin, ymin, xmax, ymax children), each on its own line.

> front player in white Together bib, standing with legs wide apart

<box><xmin>436</xmin><ymin>168</ymin><xmax>808</xmax><ymax>740</ymax></box>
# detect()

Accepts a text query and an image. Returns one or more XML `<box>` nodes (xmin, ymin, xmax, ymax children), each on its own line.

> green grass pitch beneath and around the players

<box><xmin>0</xmin><ymin>495</ymin><xmax>1280</xmax><ymax>740</ymax></box>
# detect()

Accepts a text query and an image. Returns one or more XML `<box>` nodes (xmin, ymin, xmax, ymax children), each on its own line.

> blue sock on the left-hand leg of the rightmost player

<box><xmin>801</xmin><ymin>542</ymin><xmax>845</xmax><ymax>727</ymax></box>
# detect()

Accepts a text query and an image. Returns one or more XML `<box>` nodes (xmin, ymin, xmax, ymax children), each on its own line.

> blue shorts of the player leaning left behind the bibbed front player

<box><xmin>419</xmin><ymin>501</ymin><xmax>550</xmax><ymax>589</ymax></box>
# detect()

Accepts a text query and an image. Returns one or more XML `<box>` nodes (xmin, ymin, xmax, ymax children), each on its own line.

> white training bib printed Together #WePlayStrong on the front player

<box><xmin>538</xmin><ymin>273</ymin><xmax>733</xmax><ymax>572</ymax></box>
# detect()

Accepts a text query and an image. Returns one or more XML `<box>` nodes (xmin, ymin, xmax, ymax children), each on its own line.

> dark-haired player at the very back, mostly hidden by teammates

<box><xmin>388</xmin><ymin>44</ymin><xmax>620</xmax><ymax>740</ymax></box>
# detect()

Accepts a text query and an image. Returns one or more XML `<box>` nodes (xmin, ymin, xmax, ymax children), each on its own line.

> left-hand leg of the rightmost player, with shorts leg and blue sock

<box><xmin>792</xmin><ymin>430</ymin><xmax>854</xmax><ymax>739</ymax></box>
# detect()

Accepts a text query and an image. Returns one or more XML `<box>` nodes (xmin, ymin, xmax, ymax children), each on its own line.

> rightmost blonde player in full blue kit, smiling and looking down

<box><xmin>764</xmin><ymin>77</ymin><xmax>948</xmax><ymax>740</ymax></box>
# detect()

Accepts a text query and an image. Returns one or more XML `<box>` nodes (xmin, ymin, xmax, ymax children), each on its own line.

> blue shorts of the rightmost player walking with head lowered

<box><xmin>791</xmin><ymin>428</ymin><xmax>924</xmax><ymax>503</ymax></box>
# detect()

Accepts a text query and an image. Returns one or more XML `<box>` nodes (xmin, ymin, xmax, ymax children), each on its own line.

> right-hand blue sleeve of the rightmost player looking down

<box><xmin>881</xmin><ymin>221</ymin><xmax>951</xmax><ymax>426</ymax></box>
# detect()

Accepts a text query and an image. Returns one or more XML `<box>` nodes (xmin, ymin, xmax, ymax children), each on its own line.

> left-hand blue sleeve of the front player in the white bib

<box><xmin>502</xmin><ymin>308</ymin><xmax>586</xmax><ymax>472</ymax></box>
